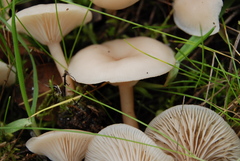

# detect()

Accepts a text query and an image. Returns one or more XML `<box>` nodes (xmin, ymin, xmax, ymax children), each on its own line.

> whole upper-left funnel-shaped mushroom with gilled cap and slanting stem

<box><xmin>8</xmin><ymin>3</ymin><xmax>92</xmax><ymax>95</ymax></box>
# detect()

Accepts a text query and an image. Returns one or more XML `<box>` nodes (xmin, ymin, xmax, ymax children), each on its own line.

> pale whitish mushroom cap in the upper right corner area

<box><xmin>173</xmin><ymin>0</ymin><xmax>223</xmax><ymax>36</ymax></box>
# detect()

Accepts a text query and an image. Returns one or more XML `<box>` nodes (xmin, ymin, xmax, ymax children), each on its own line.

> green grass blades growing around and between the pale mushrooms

<box><xmin>0</xmin><ymin>0</ymin><xmax>240</xmax><ymax>160</ymax></box>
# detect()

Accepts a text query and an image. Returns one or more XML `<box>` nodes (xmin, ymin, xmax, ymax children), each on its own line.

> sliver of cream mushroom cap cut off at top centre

<box><xmin>91</xmin><ymin>0</ymin><xmax>139</xmax><ymax>10</ymax></box>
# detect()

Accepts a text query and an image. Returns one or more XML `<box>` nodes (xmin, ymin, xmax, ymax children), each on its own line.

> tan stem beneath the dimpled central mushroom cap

<box><xmin>118</xmin><ymin>81</ymin><xmax>138</xmax><ymax>128</ymax></box>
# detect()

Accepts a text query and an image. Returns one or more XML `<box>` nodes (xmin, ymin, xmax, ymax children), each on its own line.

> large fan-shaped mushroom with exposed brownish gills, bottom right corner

<box><xmin>145</xmin><ymin>105</ymin><xmax>240</xmax><ymax>161</ymax></box>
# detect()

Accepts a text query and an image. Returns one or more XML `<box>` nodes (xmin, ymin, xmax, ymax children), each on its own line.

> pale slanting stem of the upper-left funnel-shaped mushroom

<box><xmin>48</xmin><ymin>42</ymin><xmax>74</xmax><ymax>96</ymax></box>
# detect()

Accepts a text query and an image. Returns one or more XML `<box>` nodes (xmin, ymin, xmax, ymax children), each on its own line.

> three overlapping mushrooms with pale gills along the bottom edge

<box><xmin>26</xmin><ymin>105</ymin><xmax>240</xmax><ymax>161</ymax></box>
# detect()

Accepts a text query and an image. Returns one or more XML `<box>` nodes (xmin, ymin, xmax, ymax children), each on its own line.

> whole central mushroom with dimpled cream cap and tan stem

<box><xmin>69</xmin><ymin>37</ymin><xmax>175</xmax><ymax>127</ymax></box>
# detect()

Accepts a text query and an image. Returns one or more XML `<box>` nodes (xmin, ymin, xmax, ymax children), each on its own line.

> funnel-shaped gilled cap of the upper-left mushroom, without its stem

<box><xmin>8</xmin><ymin>3</ymin><xmax>92</xmax><ymax>45</ymax></box>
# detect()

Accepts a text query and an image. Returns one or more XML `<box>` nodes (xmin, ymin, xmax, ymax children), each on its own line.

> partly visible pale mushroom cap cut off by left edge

<box><xmin>0</xmin><ymin>61</ymin><xmax>16</xmax><ymax>86</ymax></box>
